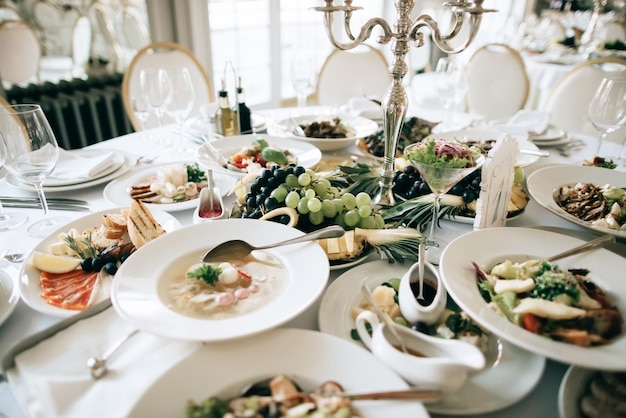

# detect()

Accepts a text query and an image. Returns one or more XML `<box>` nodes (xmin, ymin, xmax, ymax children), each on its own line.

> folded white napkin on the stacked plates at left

<box><xmin>49</xmin><ymin>148</ymin><xmax>115</xmax><ymax>180</ymax></box>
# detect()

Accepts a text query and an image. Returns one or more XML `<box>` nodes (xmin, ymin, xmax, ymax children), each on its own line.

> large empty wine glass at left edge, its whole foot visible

<box><xmin>0</xmin><ymin>104</ymin><xmax>69</xmax><ymax>238</ymax></box>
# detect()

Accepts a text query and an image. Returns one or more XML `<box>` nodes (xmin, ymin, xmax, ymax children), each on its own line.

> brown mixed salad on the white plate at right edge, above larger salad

<box><xmin>554</xmin><ymin>183</ymin><xmax>626</xmax><ymax>231</ymax></box>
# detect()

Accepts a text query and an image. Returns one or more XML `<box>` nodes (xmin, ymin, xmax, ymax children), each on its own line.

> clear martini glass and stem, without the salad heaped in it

<box><xmin>404</xmin><ymin>142</ymin><xmax>485</xmax><ymax>264</ymax></box>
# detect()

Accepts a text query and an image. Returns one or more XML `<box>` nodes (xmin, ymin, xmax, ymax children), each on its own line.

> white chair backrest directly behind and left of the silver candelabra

<box><xmin>316</xmin><ymin>45</ymin><xmax>391</xmax><ymax>105</ymax></box>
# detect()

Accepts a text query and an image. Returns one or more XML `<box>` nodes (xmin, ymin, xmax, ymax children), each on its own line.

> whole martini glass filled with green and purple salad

<box><xmin>404</xmin><ymin>138</ymin><xmax>485</xmax><ymax>264</ymax></box>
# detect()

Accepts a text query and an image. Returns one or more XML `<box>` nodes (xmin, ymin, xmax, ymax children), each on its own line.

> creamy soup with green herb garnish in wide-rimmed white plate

<box><xmin>167</xmin><ymin>254</ymin><xmax>285</xmax><ymax>319</ymax></box>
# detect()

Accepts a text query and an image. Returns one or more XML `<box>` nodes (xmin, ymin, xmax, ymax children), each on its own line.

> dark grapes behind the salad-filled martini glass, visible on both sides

<box><xmin>393</xmin><ymin>165</ymin><xmax>481</xmax><ymax>203</ymax></box>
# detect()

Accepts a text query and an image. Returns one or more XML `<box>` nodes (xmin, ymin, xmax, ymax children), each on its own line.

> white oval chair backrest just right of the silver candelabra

<box><xmin>467</xmin><ymin>44</ymin><xmax>530</xmax><ymax>119</ymax></box>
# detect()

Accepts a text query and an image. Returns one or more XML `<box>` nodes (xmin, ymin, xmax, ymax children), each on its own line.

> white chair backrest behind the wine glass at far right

<box><xmin>543</xmin><ymin>57</ymin><xmax>626</xmax><ymax>140</ymax></box>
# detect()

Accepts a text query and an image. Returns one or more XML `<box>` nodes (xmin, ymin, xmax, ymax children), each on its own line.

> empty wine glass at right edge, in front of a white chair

<box><xmin>588</xmin><ymin>78</ymin><xmax>626</xmax><ymax>158</ymax></box>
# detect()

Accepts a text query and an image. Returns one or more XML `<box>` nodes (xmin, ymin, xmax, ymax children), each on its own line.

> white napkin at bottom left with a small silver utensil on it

<box><xmin>6</xmin><ymin>308</ymin><xmax>201</xmax><ymax>418</ymax></box>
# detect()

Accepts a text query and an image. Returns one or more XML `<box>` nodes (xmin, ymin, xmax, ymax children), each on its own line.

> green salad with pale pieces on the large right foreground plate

<box><xmin>473</xmin><ymin>260</ymin><xmax>623</xmax><ymax>346</ymax></box>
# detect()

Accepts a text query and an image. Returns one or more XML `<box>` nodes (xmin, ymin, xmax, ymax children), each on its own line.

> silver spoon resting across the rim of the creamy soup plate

<box><xmin>202</xmin><ymin>225</ymin><xmax>346</xmax><ymax>263</ymax></box>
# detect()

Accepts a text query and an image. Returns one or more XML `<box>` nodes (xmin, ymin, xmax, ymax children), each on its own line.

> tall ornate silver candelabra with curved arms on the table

<box><xmin>314</xmin><ymin>0</ymin><xmax>495</xmax><ymax>205</ymax></box>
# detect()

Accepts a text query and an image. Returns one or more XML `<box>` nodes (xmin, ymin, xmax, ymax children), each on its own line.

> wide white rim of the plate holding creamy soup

<box><xmin>111</xmin><ymin>219</ymin><xmax>329</xmax><ymax>341</ymax></box>
